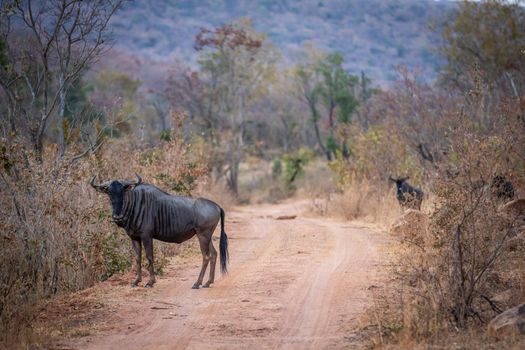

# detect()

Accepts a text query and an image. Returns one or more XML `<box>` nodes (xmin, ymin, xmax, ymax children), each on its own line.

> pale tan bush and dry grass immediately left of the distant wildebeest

<box><xmin>318</xmin><ymin>119</ymin><xmax>425</xmax><ymax>229</ymax></box>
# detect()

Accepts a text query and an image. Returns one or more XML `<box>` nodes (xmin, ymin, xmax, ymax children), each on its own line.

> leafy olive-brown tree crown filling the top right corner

<box><xmin>440</xmin><ymin>0</ymin><xmax>525</xmax><ymax>97</ymax></box>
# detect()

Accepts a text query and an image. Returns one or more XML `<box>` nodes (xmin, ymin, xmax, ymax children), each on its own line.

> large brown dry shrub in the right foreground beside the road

<box><xmin>380</xmin><ymin>91</ymin><xmax>525</xmax><ymax>344</ymax></box>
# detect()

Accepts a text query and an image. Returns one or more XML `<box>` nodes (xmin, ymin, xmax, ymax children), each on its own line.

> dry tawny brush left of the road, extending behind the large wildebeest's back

<box><xmin>0</xmin><ymin>130</ymin><xmax>207</xmax><ymax>343</ymax></box>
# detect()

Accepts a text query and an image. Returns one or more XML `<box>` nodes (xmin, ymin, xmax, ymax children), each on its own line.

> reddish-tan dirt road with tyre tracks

<box><xmin>63</xmin><ymin>202</ymin><xmax>383</xmax><ymax>350</ymax></box>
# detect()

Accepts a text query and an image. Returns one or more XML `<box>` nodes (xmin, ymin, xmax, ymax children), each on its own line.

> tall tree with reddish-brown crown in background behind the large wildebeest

<box><xmin>189</xmin><ymin>20</ymin><xmax>277</xmax><ymax>194</ymax></box>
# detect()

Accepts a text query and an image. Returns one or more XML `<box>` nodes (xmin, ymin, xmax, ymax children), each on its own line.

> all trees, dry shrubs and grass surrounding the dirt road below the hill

<box><xmin>0</xmin><ymin>0</ymin><xmax>525</xmax><ymax>347</ymax></box>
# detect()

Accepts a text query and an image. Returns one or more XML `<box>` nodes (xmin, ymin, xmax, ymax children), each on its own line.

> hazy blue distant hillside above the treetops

<box><xmin>106</xmin><ymin>0</ymin><xmax>455</xmax><ymax>85</ymax></box>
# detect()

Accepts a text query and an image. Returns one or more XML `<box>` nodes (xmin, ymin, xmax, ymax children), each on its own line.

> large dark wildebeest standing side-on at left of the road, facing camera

<box><xmin>89</xmin><ymin>174</ymin><xmax>228</xmax><ymax>289</ymax></box>
